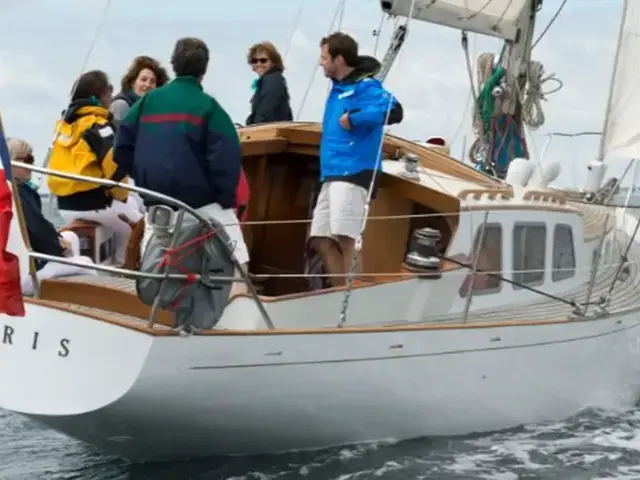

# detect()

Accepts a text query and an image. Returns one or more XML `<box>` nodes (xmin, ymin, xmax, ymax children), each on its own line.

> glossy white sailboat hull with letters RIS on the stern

<box><xmin>0</xmin><ymin>304</ymin><xmax>640</xmax><ymax>460</ymax></box>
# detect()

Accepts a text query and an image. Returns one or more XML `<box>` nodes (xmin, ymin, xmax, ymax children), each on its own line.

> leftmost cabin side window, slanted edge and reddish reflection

<box><xmin>459</xmin><ymin>223</ymin><xmax>502</xmax><ymax>297</ymax></box>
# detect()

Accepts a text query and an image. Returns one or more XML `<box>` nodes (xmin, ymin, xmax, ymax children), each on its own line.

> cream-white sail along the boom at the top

<box><xmin>380</xmin><ymin>0</ymin><xmax>531</xmax><ymax>40</ymax></box>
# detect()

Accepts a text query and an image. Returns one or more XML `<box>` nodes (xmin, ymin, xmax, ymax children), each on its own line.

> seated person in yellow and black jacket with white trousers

<box><xmin>48</xmin><ymin>70</ymin><xmax>142</xmax><ymax>264</ymax></box>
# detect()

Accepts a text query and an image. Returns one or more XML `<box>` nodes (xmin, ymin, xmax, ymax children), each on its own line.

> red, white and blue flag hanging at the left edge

<box><xmin>0</xmin><ymin>110</ymin><xmax>25</xmax><ymax>317</ymax></box>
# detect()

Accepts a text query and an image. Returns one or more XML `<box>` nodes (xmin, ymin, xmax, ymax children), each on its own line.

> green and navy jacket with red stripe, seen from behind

<box><xmin>113</xmin><ymin>77</ymin><xmax>242</xmax><ymax>208</ymax></box>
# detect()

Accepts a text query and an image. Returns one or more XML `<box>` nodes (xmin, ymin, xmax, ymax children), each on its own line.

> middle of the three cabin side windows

<box><xmin>513</xmin><ymin>223</ymin><xmax>547</xmax><ymax>289</ymax></box>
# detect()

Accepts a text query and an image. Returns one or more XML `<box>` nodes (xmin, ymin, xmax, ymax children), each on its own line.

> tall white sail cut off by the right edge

<box><xmin>600</xmin><ymin>0</ymin><xmax>640</xmax><ymax>158</ymax></box>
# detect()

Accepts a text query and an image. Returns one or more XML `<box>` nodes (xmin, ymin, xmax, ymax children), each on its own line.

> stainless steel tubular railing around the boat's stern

<box><xmin>11</xmin><ymin>161</ymin><xmax>275</xmax><ymax>330</ymax></box>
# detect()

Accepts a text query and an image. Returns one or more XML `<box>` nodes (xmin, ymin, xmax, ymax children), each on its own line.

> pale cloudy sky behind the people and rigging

<box><xmin>0</xmin><ymin>0</ymin><xmax>631</xmax><ymax>187</ymax></box>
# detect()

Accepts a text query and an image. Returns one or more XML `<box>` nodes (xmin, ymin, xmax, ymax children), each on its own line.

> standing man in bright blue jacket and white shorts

<box><xmin>310</xmin><ymin>32</ymin><xmax>403</xmax><ymax>286</ymax></box>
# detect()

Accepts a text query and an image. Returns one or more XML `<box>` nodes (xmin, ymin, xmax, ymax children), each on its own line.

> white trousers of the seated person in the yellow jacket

<box><xmin>60</xmin><ymin>199</ymin><xmax>143</xmax><ymax>265</ymax></box>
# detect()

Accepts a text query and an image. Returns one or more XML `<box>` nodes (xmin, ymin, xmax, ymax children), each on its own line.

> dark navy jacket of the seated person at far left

<box><xmin>18</xmin><ymin>185</ymin><xmax>63</xmax><ymax>257</ymax></box>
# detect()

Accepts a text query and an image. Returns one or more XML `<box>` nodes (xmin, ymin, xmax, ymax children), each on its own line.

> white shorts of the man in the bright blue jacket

<box><xmin>309</xmin><ymin>181</ymin><xmax>367</xmax><ymax>239</ymax></box>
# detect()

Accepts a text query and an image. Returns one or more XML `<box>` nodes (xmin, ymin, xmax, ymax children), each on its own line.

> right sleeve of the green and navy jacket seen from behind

<box><xmin>204</xmin><ymin>104</ymin><xmax>242</xmax><ymax>208</ymax></box>
